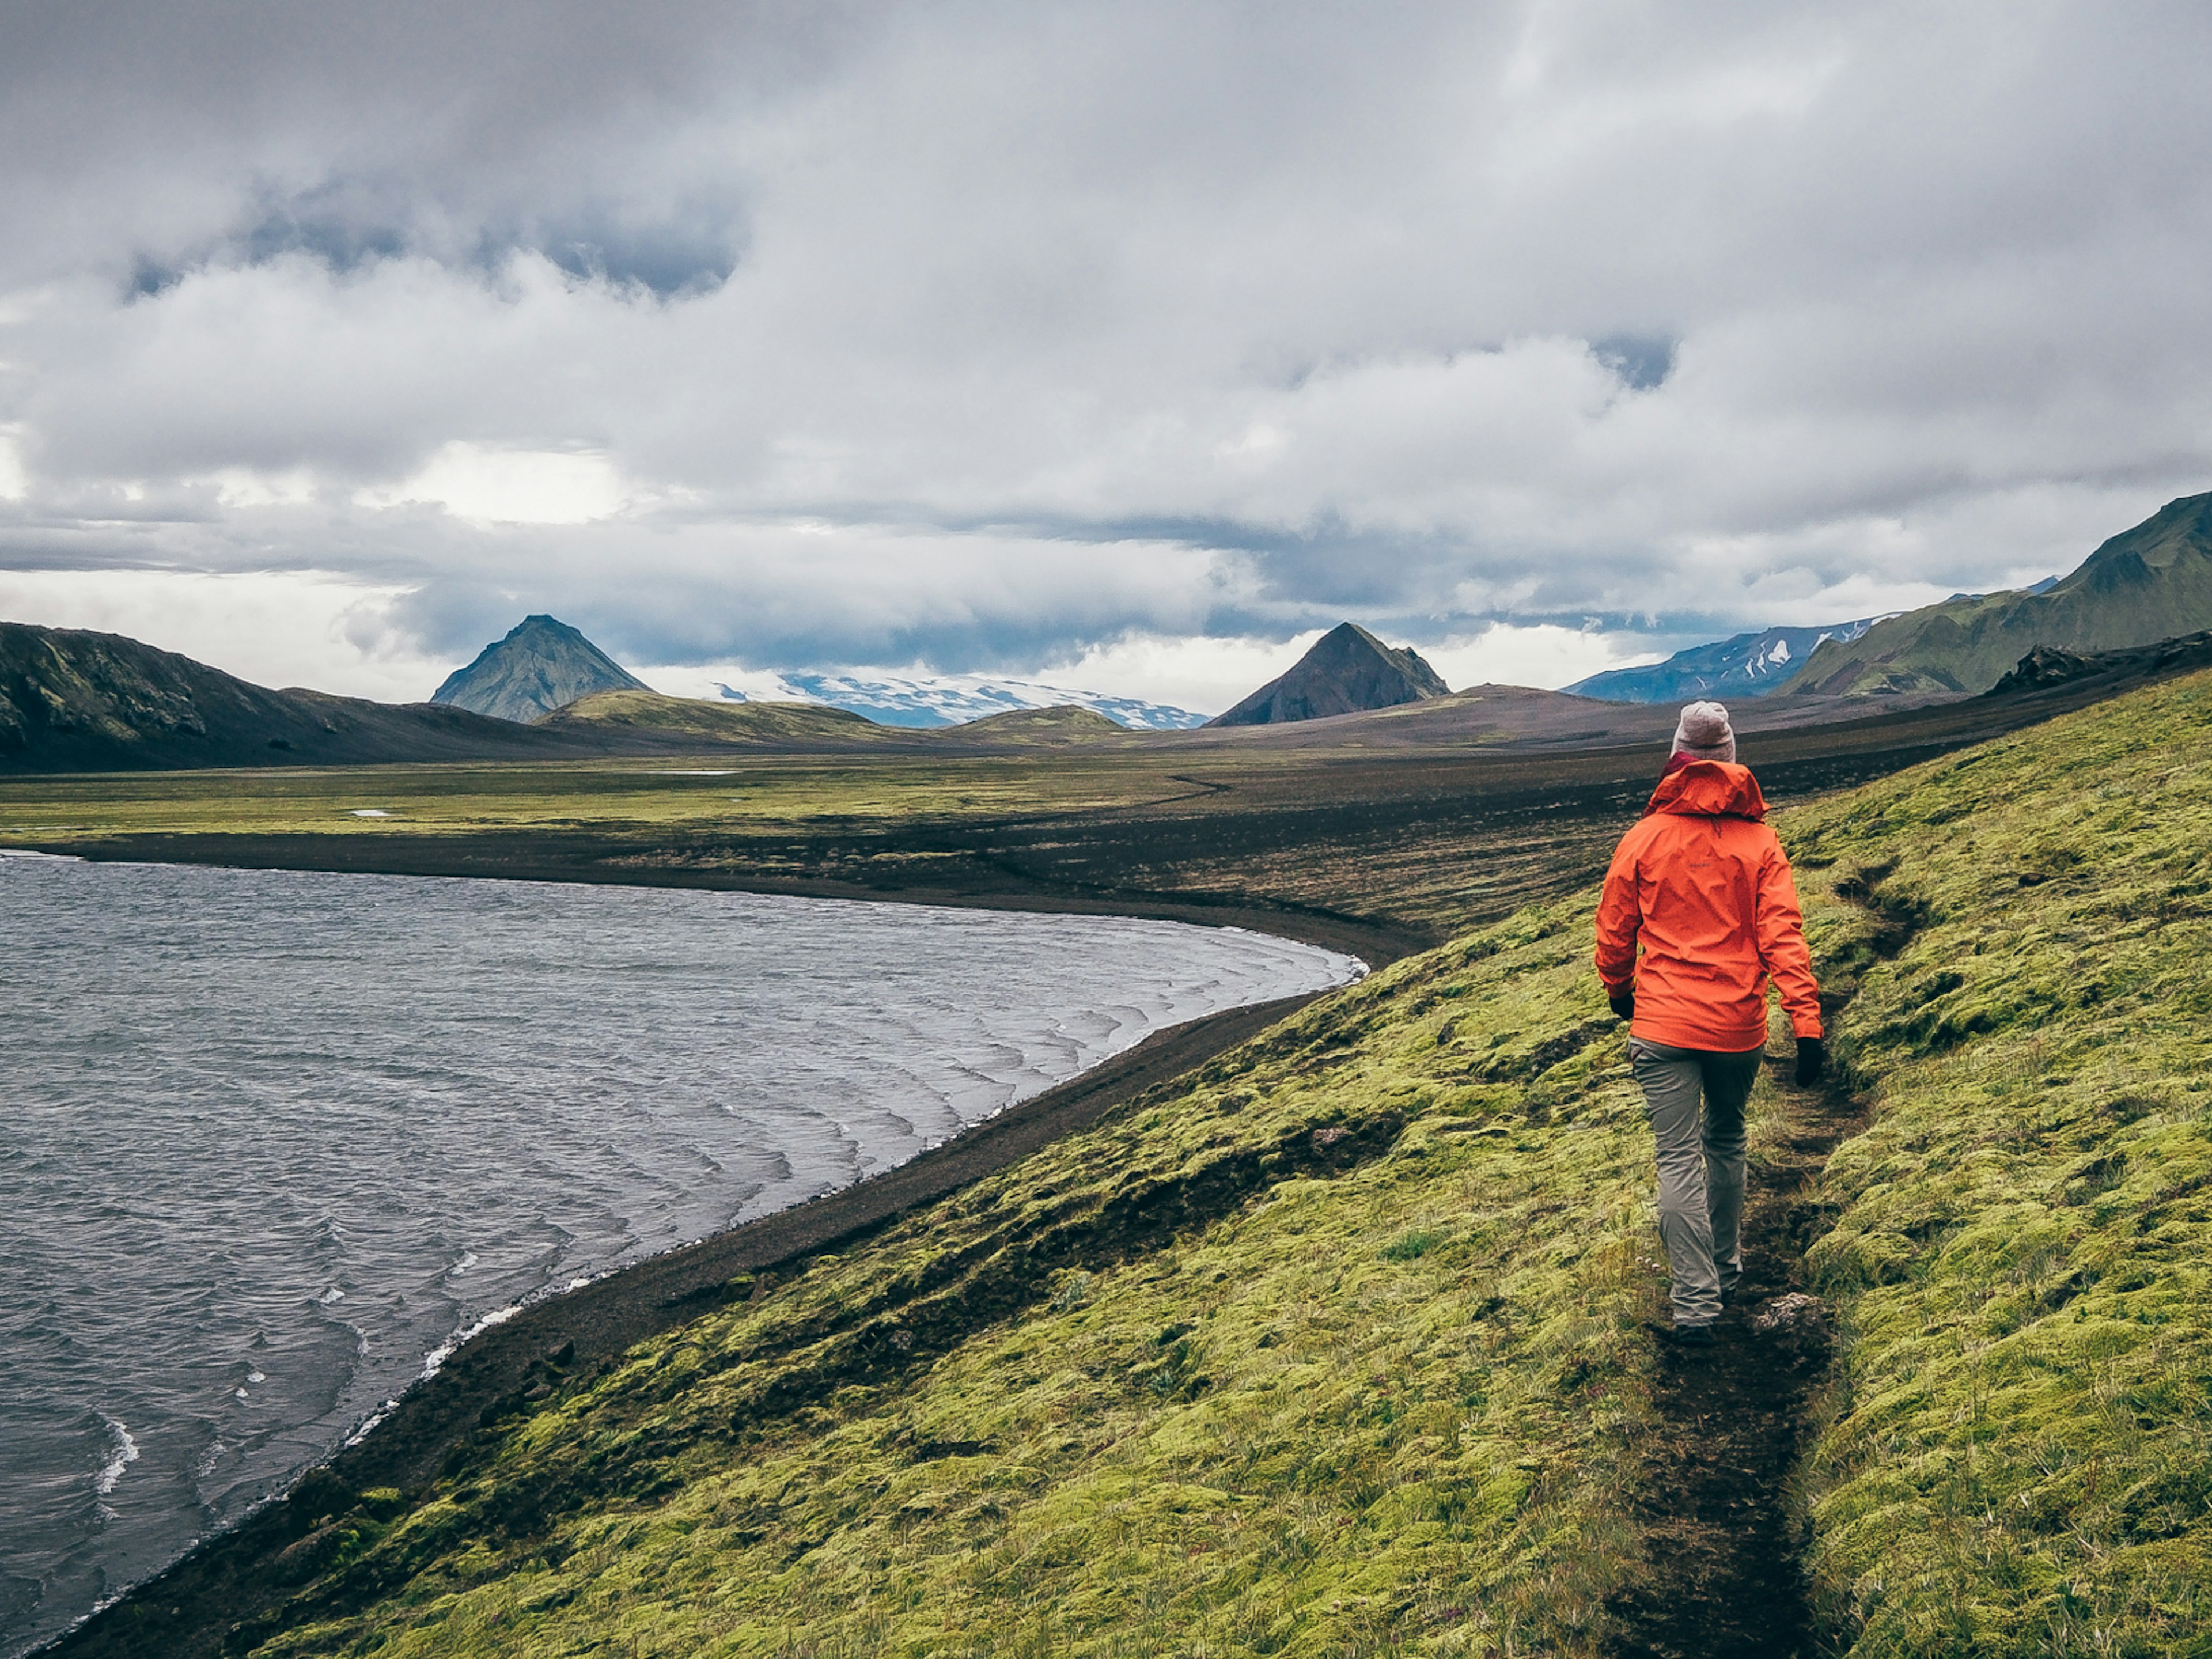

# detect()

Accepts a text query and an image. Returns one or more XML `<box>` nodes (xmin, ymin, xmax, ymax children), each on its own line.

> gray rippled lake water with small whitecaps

<box><xmin>0</xmin><ymin>856</ymin><xmax>1361</xmax><ymax>1654</ymax></box>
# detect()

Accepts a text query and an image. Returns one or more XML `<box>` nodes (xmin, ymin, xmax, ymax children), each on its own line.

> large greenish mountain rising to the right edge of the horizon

<box><xmin>1783</xmin><ymin>495</ymin><xmax>2212</xmax><ymax>697</ymax></box>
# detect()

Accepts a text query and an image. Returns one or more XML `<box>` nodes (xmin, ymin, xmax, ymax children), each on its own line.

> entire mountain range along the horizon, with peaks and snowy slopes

<box><xmin>17</xmin><ymin>493</ymin><xmax>2212</xmax><ymax>772</ymax></box>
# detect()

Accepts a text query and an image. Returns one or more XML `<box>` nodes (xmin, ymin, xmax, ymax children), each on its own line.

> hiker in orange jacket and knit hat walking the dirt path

<box><xmin>1597</xmin><ymin>703</ymin><xmax>1827</xmax><ymax>1345</ymax></box>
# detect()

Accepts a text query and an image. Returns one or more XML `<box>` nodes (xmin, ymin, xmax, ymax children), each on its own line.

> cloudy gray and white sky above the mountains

<box><xmin>0</xmin><ymin>0</ymin><xmax>2212</xmax><ymax>708</ymax></box>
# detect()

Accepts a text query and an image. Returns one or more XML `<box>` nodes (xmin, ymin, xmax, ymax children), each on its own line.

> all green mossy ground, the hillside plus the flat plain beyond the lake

<box><xmin>30</xmin><ymin>672</ymin><xmax>2212</xmax><ymax>1659</ymax></box>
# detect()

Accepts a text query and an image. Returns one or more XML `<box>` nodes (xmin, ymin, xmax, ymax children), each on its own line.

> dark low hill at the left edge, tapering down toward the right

<box><xmin>0</xmin><ymin>622</ymin><xmax>601</xmax><ymax>772</ymax></box>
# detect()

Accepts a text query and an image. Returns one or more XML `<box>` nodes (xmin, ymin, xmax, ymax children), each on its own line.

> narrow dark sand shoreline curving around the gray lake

<box><xmin>29</xmin><ymin>858</ymin><xmax>1431</xmax><ymax>1659</ymax></box>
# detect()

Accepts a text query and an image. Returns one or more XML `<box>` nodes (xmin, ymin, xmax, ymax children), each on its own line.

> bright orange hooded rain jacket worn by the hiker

<box><xmin>1597</xmin><ymin>756</ymin><xmax>1820</xmax><ymax>1053</ymax></box>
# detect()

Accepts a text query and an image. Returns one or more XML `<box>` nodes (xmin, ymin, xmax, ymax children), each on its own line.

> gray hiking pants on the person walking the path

<box><xmin>1628</xmin><ymin>1037</ymin><xmax>1761</xmax><ymax>1325</ymax></box>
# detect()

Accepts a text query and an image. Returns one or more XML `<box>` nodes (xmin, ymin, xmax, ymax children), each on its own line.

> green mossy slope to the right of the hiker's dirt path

<box><xmin>1790</xmin><ymin>675</ymin><xmax>2212</xmax><ymax>1659</ymax></box>
